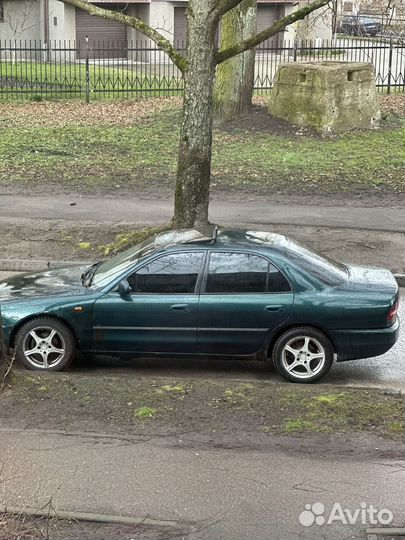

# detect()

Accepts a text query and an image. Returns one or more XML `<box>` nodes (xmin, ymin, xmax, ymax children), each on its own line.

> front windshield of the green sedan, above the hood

<box><xmin>91</xmin><ymin>237</ymin><xmax>155</xmax><ymax>289</ymax></box>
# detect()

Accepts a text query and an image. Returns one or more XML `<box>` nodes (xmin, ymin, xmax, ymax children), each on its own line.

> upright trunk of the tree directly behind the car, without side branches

<box><xmin>173</xmin><ymin>0</ymin><xmax>216</xmax><ymax>228</ymax></box>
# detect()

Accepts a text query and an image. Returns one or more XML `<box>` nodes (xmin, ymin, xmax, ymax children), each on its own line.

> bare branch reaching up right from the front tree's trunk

<box><xmin>216</xmin><ymin>0</ymin><xmax>329</xmax><ymax>64</ymax></box>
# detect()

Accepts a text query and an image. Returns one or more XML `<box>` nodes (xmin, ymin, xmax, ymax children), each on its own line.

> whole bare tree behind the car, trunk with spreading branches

<box><xmin>61</xmin><ymin>0</ymin><xmax>328</xmax><ymax>227</ymax></box>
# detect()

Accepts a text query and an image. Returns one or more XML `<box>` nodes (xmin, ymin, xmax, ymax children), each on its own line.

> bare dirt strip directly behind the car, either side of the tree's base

<box><xmin>0</xmin><ymin>220</ymin><xmax>405</xmax><ymax>272</ymax></box>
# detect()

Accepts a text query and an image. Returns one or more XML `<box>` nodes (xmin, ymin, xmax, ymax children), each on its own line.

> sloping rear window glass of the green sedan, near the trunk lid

<box><xmin>286</xmin><ymin>241</ymin><xmax>348</xmax><ymax>287</ymax></box>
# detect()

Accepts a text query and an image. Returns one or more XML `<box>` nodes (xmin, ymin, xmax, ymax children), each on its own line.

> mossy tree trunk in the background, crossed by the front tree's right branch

<box><xmin>214</xmin><ymin>0</ymin><xmax>257</xmax><ymax>123</ymax></box>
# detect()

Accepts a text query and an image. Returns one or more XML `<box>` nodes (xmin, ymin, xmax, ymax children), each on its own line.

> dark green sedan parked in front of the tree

<box><xmin>0</xmin><ymin>229</ymin><xmax>399</xmax><ymax>383</ymax></box>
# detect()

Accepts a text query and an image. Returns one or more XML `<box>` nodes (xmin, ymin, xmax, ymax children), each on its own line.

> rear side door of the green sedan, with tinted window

<box><xmin>197</xmin><ymin>250</ymin><xmax>293</xmax><ymax>355</ymax></box>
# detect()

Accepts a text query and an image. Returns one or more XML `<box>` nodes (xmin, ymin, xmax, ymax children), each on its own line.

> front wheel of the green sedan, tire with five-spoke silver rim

<box><xmin>15</xmin><ymin>317</ymin><xmax>76</xmax><ymax>371</ymax></box>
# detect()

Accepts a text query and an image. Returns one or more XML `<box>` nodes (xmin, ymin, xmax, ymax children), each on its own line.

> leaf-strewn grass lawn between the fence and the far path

<box><xmin>0</xmin><ymin>98</ymin><xmax>405</xmax><ymax>194</ymax></box>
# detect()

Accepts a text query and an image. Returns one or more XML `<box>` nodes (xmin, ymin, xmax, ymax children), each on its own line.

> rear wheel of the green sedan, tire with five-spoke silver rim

<box><xmin>272</xmin><ymin>326</ymin><xmax>333</xmax><ymax>384</ymax></box>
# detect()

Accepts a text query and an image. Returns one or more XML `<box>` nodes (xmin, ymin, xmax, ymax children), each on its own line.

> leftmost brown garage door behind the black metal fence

<box><xmin>76</xmin><ymin>4</ymin><xmax>127</xmax><ymax>58</ymax></box>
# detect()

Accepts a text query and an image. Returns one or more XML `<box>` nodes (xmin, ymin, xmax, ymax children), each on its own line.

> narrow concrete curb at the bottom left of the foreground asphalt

<box><xmin>0</xmin><ymin>506</ymin><xmax>179</xmax><ymax>528</ymax></box>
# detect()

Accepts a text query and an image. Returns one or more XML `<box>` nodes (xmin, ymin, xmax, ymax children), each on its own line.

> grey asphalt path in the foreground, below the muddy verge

<box><xmin>0</xmin><ymin>426</ymin><xmax>405</xmax><ymax>540</ymax></box>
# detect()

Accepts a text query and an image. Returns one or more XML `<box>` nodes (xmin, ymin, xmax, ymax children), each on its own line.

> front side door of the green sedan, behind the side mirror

<box><xmin>93</xmin><ymin>251</ymin><xmax>204</xmax><ymax>354</ymax></box>
